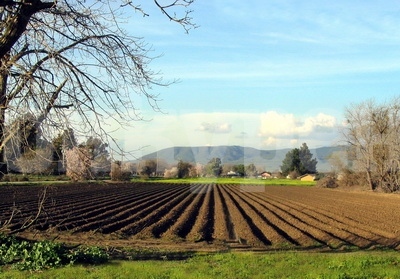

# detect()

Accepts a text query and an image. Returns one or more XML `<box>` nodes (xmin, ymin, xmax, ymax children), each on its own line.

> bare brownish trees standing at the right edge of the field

<box><xmin>343</xmin><ymin>98</ymin><xmax>400</xmax><ymax>192</ymax></box>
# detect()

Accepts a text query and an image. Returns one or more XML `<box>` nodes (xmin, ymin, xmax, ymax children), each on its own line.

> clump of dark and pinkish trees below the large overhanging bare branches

<box><xmin>4</xmin><ymin>118</ymin><xmax>111</xmax><ymax>182</ymax></box>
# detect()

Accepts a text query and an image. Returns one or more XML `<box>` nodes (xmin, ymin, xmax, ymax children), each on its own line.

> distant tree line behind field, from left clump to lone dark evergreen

<box><xmin>1</xmin><ymin>115</ymin><xmax>317</xmax><ymax>184</ymax></box>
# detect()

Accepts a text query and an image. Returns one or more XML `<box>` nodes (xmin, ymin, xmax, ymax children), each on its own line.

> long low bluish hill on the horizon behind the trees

<box><xmin>141</xmin><ymin>146</ymin><xmax>343</xmax><ymax>172</ymax></box>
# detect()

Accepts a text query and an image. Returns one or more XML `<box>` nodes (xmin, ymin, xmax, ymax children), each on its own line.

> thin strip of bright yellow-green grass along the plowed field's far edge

<box><xmin>138</xmin><ymin>177</ymin><xmax>316</xmax><ymax>186</ymax></box>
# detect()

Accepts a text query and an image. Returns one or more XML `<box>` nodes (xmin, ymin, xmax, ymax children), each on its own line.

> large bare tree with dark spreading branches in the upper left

<box><xmin>0</xmin><ymin>0</ymin><xmax>195</xmax><ymax>177</ymax></box>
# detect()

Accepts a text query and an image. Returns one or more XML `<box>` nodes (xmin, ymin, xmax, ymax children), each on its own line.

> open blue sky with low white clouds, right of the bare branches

<box><xmin>108</xmin><ymin>0</ymin><xmax>400</xmax><ymax>159</ymax></box>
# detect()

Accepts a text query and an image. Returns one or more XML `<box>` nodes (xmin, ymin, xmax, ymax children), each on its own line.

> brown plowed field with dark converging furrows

<box><xmin>0</xmin><ymin>183</ymin><xmax>400</xmax><ymax>253</ymax></box>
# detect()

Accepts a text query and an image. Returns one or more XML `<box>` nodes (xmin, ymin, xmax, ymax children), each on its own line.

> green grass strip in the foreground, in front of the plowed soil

<box><xmin>0</xmin><ymin>251</ymin><xmax>400</xmax><ymax>279</ymax></box>
